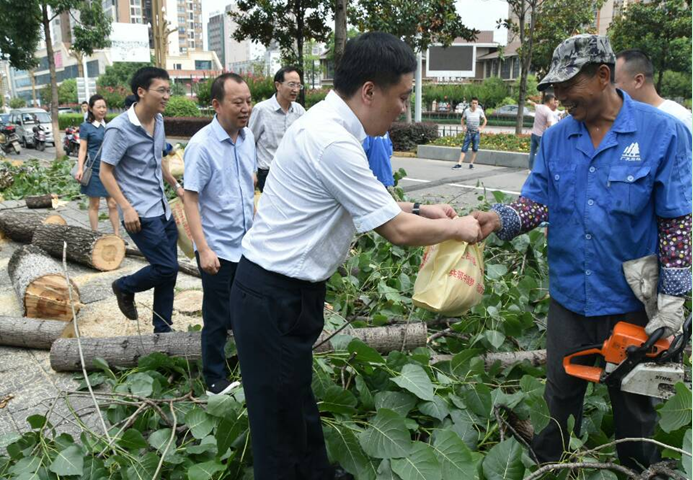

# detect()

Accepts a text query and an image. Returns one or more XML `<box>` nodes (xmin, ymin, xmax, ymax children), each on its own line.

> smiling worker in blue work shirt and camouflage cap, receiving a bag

<box><xmin>474</xmin><ymin>35</ymin><xmax>691</xmax><ymax>470</ymax></box>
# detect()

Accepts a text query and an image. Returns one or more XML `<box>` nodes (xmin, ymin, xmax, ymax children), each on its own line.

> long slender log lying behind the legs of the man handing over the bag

<box><xmin>50</xmin><ymin>323</ymin><xmax>426</xmax><ymax>372</ymax></box>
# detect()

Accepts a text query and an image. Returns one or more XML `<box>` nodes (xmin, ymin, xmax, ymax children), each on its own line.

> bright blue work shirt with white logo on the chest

<box><xmin>522</xmin><ymin>90</ymin><xmax>691</xmax><ymax>317</ymax></box>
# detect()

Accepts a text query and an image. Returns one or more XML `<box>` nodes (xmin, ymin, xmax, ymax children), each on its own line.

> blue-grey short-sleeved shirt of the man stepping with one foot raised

<box><xmin>101</xmin><ymin>104</ymin><xmax>171</xmax><ymax>219</ymax></box>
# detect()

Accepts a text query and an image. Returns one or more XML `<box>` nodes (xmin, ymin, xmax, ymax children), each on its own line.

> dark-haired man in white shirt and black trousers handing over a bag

<box><xmin>231</xmin><ymin>32</ymin><xmax>481</xmax><ymax>480</ymax></box>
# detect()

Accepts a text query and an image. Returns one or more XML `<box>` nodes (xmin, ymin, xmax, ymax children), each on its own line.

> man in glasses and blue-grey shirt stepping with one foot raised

<box><xmin>99</xmin><ymin>67</ymin><xmax>185</xmax><ymax>333</ymax></box>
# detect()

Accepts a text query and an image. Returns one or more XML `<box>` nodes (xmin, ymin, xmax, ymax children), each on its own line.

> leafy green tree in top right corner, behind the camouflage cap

<box><xmin>609</xmin><ymin>0</ymin><xmax>691</xmax><ymax>92</ymax></box>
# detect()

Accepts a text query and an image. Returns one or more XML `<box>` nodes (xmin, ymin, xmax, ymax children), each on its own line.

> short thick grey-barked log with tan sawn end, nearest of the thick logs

<box><xmin>7</xmin><ymin>245</ymin><xmax>81</xmax><ymax>321</ymax></box>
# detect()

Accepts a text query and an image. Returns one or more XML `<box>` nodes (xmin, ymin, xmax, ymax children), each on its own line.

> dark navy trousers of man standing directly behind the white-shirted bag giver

<box><xmin>195</xmin><ymin>252</ymin><xmax>238</xmax><ymax>386</ymax></box>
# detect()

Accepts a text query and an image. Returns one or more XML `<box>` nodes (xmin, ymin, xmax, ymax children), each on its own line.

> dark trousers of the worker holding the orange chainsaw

<box><xmin>532</xmin><ymin>300</ymin><xmax>659</xmax><ymax>470</ymax></box>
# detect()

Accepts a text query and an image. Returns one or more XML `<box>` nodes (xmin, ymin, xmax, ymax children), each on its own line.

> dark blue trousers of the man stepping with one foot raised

<box><xmin>118</xmin><ymin>215</ymin><xmax>178</xmax><ymax>333</ymax></box>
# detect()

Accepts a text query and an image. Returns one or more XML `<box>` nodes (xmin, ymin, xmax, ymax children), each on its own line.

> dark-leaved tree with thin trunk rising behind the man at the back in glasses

<box><xmin>229</xmin><ymin>0</ymin><xmax>333</xmax><ymax>104</ymax></box>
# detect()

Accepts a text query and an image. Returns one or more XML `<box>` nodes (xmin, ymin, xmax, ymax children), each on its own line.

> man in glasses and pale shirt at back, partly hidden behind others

<box><xmin>248</xmin><ymin>67</ymin><xmax>306</xmax><ymax>192</ymax></box>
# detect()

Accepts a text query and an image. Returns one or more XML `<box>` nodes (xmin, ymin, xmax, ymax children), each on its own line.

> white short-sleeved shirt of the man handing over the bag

<box><xmin>243</xmin><ymin>92</ymin><xmax>402</xmax><ymax>282</ymax></box>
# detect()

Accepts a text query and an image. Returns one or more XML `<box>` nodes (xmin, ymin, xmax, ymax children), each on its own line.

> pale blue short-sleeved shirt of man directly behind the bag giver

<box><xmin>184</xmin><ymin>116</ymin><xmax>256</xmax><ymax>262</ymax></box>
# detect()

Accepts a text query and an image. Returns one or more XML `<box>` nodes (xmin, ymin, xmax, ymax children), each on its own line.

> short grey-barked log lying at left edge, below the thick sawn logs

<box><xmin>0</xmin><ymin>316</ymin><xmax>69</xmax><ymax>350</ymax></box>
